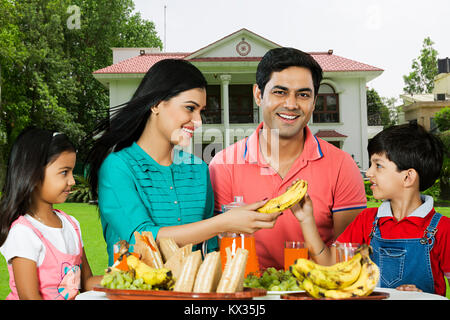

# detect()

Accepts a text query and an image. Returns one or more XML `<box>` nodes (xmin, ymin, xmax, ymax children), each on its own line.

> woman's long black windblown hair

<box><xmin>85</xmin><ymin>59</ymin><xmax>206</xmax><ymax>198</ymax></box>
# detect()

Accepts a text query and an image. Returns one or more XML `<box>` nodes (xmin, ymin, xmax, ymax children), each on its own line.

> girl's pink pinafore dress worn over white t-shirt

<box><xmin>6</xmin><ymin>210</ymin><xmax>83</xmax><ymax>300</ymax></box>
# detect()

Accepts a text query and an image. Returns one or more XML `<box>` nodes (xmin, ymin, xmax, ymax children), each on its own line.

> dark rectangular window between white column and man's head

<box><xmin>229</xmin><ymin>84</ymin><xmax>253</xmax><ymax>123</ymax></box>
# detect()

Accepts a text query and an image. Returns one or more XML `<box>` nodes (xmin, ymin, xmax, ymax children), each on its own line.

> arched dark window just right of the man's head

<box><xmin>313</xmin><ymin>84</ymin><xmax>339</xmax><ymax>123</ymax></box>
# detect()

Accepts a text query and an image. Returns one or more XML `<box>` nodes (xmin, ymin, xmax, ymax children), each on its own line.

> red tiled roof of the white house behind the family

<box><xmin>94</xmin><ymin>52</ymin><xmax>383</xmax><ymax>74</ymax></box>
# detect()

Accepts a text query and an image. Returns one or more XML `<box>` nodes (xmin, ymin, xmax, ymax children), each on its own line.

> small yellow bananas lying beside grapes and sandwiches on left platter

<box><xmin>127</xmin><ymin>255</ymin><xmax>172</xmax><ymax>286</ymax></box>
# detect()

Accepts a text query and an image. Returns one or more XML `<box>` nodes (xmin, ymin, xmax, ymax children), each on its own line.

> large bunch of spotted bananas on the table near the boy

<box><xmin>290</xmin><ymin>245</ymin><xmax>380</xmax><ymax>299</ymax></box>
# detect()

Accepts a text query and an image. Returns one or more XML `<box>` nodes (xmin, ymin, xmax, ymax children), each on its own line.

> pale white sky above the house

<box><xmin>134</xmin><ymin>0</ymin><xmax>450</xmax><ymax>104</ymax></box>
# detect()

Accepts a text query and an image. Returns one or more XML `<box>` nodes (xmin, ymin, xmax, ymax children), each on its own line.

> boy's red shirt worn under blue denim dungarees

<box><xmin>336</xmin><ymin>202</ymin><xmax>450</xmax><ymax>296</ymax></box>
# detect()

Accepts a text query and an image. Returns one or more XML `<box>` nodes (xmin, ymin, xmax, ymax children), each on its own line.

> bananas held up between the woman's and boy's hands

<box><xmin>256</xmin><ymin>180</ymin><xmax>308</xmax><ymax>213</ymax></box>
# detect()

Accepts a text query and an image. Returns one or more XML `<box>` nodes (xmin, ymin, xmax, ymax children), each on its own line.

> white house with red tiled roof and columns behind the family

<box><xmin>93</xmin><ymin>29</ymin><xmax>383</xmax><ymax>170</ymax></box>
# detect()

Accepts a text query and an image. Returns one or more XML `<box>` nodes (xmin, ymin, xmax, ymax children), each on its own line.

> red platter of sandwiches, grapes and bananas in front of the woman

<box><xmin>94</xmin><ymin>232</ymin><xmax>267</xmax><ymax>300</ymax></box>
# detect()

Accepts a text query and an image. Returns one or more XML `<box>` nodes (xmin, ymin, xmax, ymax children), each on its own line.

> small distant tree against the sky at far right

<box><xmin>403</xmin><ymin>37</ymin><xmax>438</xmax><ymax>94</ymax></box>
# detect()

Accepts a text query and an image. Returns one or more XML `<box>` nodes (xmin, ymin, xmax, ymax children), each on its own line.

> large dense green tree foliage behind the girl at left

<box><xmin>0</xmin><ymin>0</ymin><xmax>162</xmax><ymax>186</ymax></box>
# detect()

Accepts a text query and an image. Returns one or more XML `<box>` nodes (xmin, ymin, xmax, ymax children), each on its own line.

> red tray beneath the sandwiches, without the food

<box><xmin>94</xmin><ymin>286</ymin><xmax>267</xmax><ymax>300</ymax></box>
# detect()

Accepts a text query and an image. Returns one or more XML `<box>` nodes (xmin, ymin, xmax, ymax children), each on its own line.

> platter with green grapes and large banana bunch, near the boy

<box><xmin>244</xmin><ymin>245</ymin><xmax>389</xmax><ymax>300</ymax></box>
